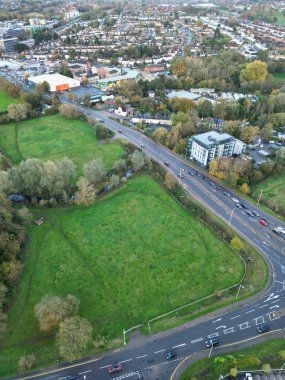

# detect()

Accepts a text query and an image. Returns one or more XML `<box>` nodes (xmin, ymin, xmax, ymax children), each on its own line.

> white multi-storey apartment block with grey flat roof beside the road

<box><xmin>188</xmin><ymin>131</ymin><xmax>246</xmax><ymax>167</ymax></box>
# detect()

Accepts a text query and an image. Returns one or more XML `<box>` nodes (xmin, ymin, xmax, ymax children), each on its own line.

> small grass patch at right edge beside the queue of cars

<box><xmin>253</xmin><ymin>175</ymin><xmax>285</xmax><ymax>210</ymax></box>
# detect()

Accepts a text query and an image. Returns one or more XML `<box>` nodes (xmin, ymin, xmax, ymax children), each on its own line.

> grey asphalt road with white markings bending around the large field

<box><xmin>8</xmin><ymin>96</ymin><xmax>285</xmax><ymax>380</ymax></box>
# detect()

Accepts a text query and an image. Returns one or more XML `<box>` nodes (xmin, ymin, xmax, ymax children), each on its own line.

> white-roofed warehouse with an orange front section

<box><xmin>29</xmin><ymin>74</ymin><xmax>80</xmax><ymax>92</ymax></box>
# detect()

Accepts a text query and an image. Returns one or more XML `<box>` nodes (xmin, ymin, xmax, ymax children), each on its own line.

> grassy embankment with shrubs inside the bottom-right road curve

<box><xmin>180</xmin><ymin>339</ymin><xmax>285</xmax><ymax>380</ymax></box>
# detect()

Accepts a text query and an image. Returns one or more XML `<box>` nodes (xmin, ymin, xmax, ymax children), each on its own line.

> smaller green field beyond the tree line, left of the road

<box><xmin>0</xmin><ymin>114</ymin><xmax>124</xmax><ymax>170</ymax></box>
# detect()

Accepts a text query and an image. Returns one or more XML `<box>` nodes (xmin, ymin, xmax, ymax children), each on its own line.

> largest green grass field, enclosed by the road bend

<box><xmin>0</xmin><ymin>175</ymin><xmax>243</xmax><ymax>376</ymax></box>
